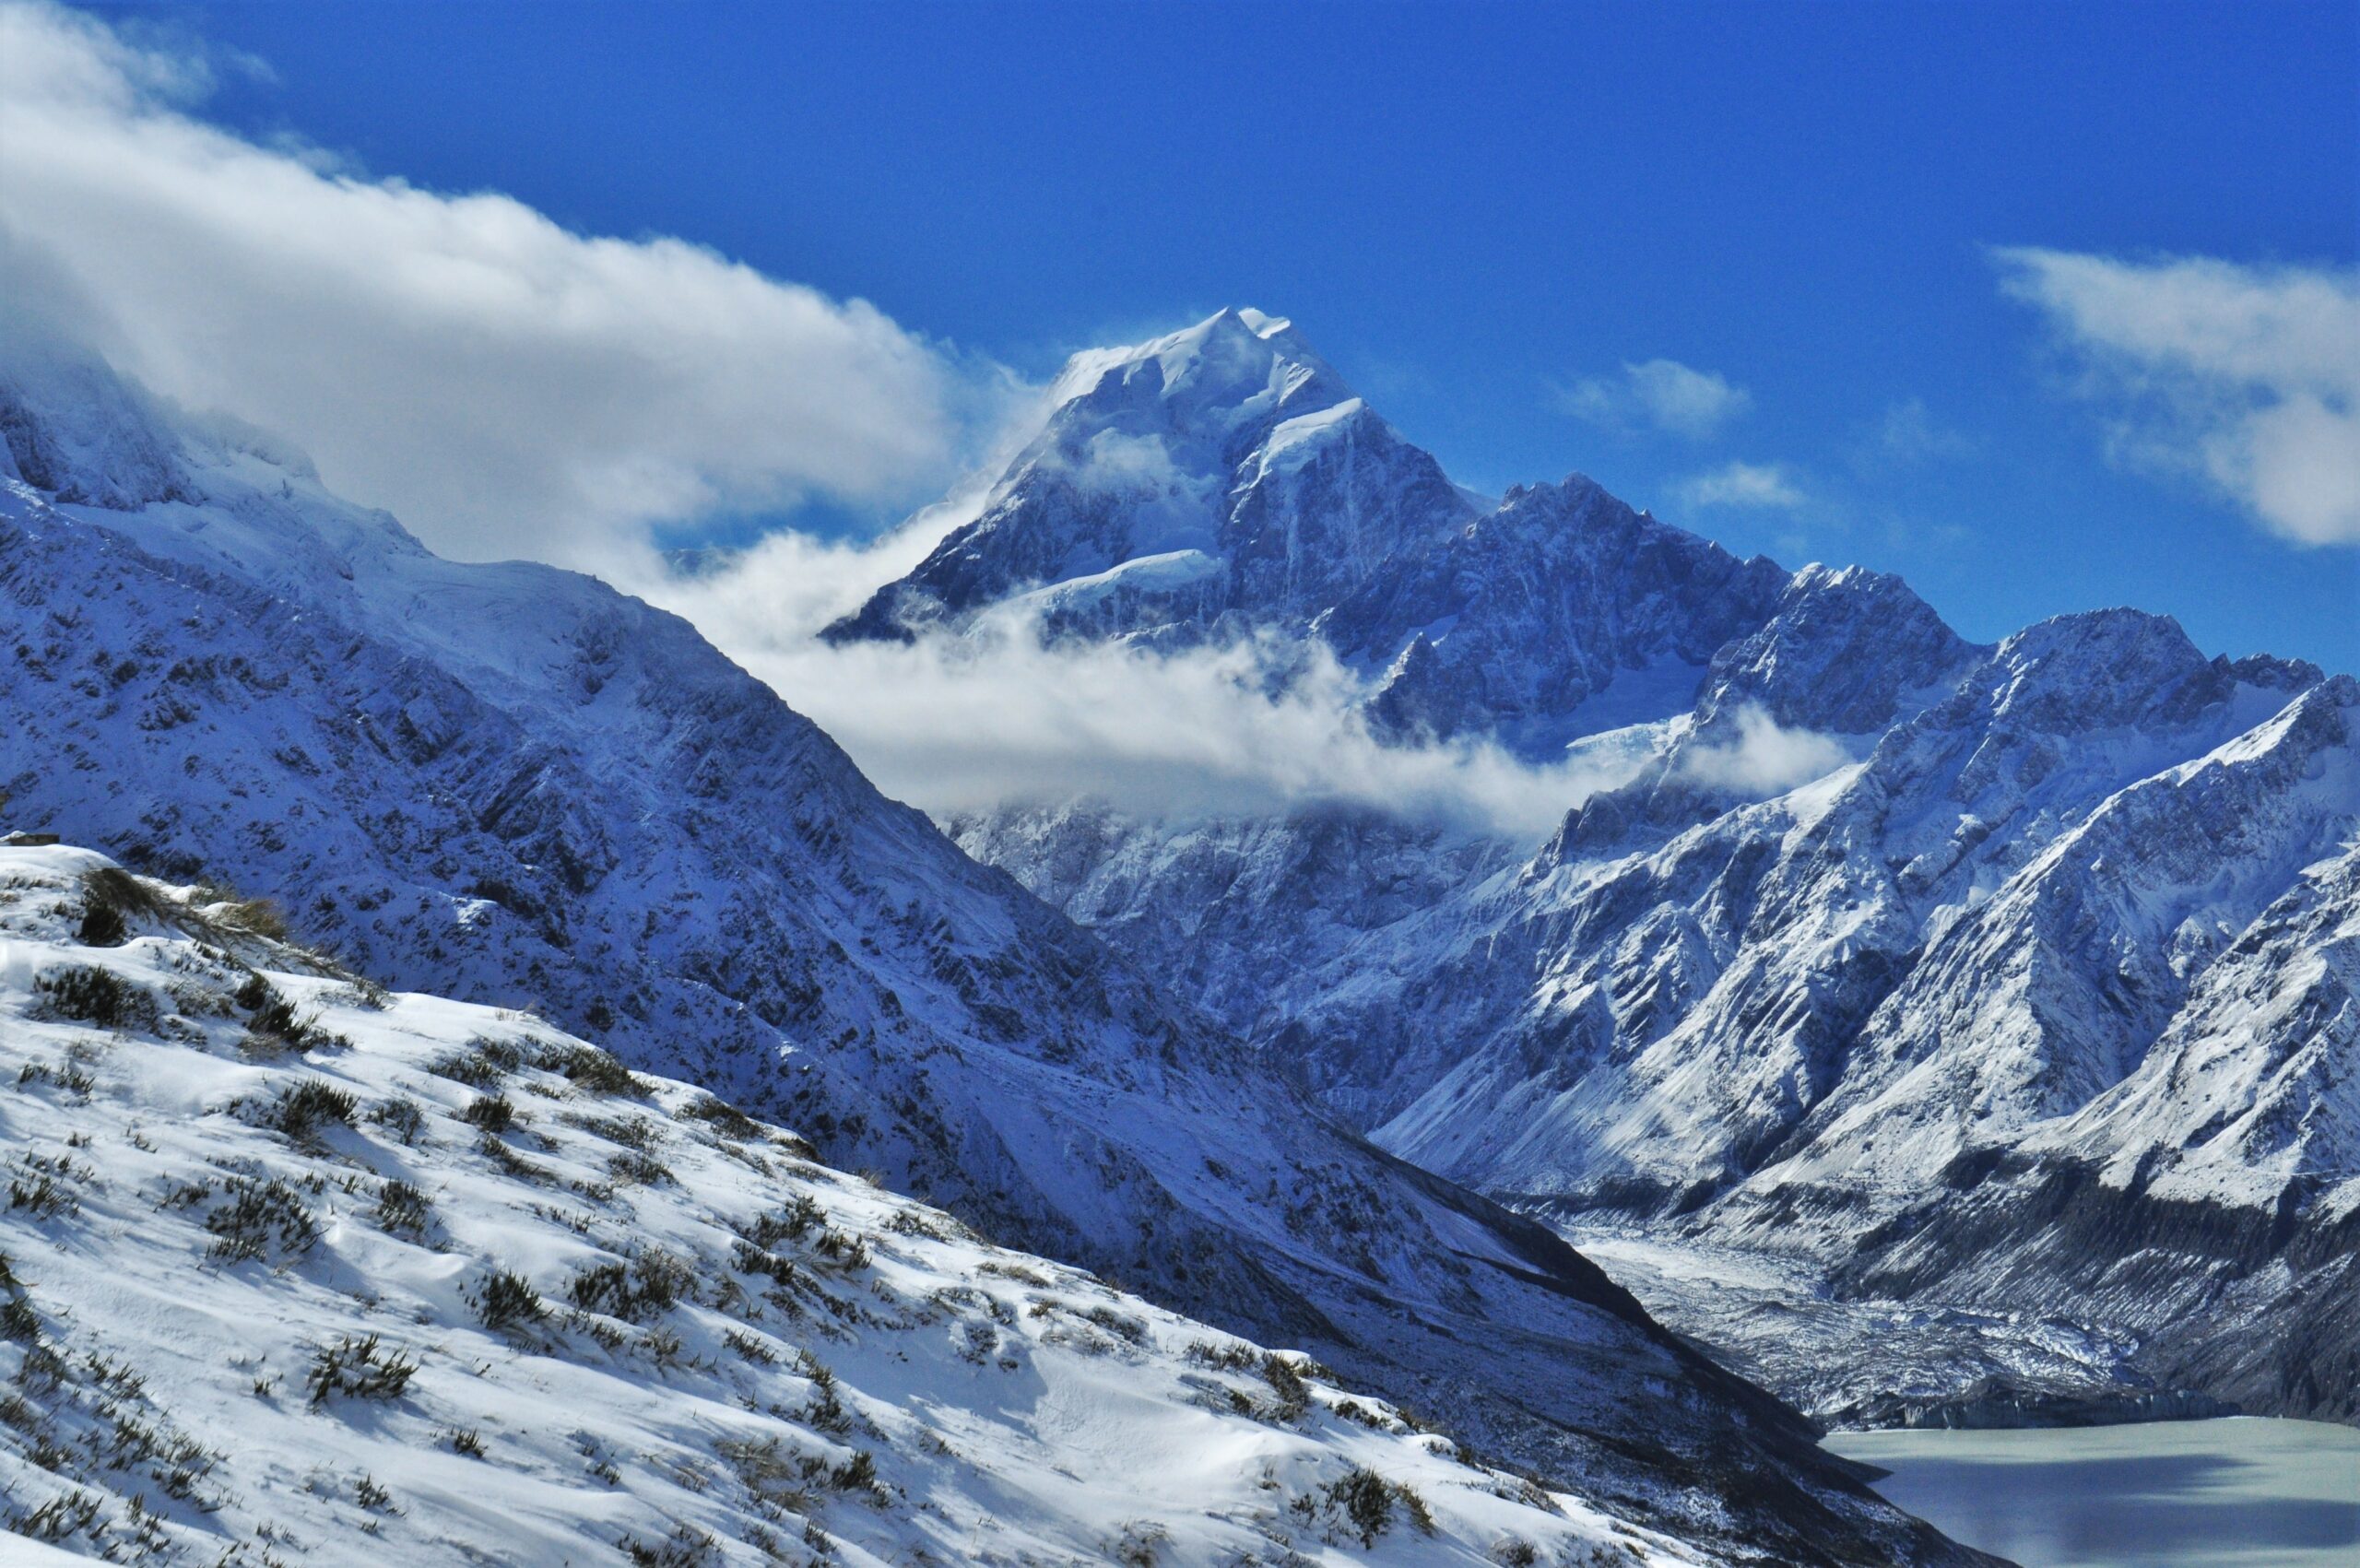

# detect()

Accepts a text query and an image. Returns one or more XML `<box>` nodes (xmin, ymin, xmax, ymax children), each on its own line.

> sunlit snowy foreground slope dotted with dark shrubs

<box><xmin>0</xmin><ymin>848</ymin><xmax>1720</xmax><ymax>1568</ymax></box>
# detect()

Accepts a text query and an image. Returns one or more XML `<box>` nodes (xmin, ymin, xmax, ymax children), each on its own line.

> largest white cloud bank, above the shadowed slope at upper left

<box><xmin>0</xmin><ymin>5</ymin><xmax>1006</xmax><ymax>564</ymax></box>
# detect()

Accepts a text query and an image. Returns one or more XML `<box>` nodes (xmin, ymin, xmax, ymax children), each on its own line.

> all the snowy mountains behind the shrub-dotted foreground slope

<box><xmin>0</xmin><ymin>300</ymin><xmax>2360</xmax><ymax>1563</ymax></box>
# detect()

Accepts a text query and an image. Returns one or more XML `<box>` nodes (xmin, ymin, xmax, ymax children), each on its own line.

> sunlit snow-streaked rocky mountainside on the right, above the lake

<box><xmin>1378</xmin><ymin>632</ymin><xmax>2360</xmax><ymax>1420</ymax></box>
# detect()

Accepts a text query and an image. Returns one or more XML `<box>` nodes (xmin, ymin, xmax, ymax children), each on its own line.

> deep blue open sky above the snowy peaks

<box><xmin>68</xmin><ymin>5</ymin><xmax>2360</xmax><ymax>668</ymax></box>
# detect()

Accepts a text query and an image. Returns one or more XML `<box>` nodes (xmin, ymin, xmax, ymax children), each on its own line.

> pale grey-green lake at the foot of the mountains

<box><xmin>1826</xmin><ymin>1420</ymin><xmax>2360</xmax><ymax>1568</ymax></box>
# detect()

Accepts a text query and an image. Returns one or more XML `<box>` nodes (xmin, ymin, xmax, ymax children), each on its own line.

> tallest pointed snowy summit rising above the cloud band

<box><xmin>826</xmin><ymin>310</ymin><xmax>1475</xmax><ymax>643</ymax></box>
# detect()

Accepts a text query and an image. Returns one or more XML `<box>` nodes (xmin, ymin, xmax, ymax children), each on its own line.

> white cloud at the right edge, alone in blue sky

<box><xmin>1994</xmin><ymin>248</ymin><xmax>2360</xmax><ymax>546</ymax></box>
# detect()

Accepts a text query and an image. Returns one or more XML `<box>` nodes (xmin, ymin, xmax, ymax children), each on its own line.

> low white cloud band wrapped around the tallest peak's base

<box><xmin>625</xmin><ymin>528</ymin><xmax>1645</xmax><ymax>838</ymax></box>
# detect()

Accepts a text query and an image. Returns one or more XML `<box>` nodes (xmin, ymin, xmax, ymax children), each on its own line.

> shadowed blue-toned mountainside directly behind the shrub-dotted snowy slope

<box><xmin>0</xmin><ymin>328</ymin><xmax>1968</xmax><ymax>1563</ymax></box>
